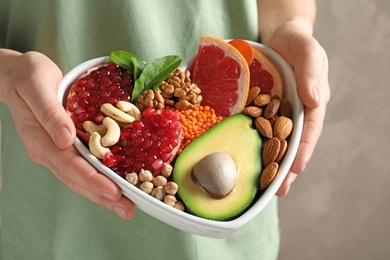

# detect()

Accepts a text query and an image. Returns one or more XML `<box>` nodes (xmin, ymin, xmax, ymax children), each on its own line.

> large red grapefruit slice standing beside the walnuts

<box><xmin>190</xmin><ymin>36</ymin><xmax>249</xmax><ymax>117</ymax></box>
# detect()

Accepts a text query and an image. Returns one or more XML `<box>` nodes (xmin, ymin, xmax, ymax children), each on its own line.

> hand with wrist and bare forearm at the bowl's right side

<box><xmin>257</xmin><ymin>0</ymin><xmax>330</xmax><ymax>196</ymax></box>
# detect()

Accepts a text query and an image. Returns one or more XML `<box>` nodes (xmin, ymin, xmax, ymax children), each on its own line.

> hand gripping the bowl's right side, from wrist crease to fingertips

<box><xmin>268</xmin><ymin>19</ymin><xmax>330</xmax><ymax>196</ymax></box>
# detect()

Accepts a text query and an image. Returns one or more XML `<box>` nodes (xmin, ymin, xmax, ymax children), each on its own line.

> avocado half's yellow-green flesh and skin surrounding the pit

<box><xmin>173</xmin><ymin>114</ymin><xmax>262</xmax><ymax>220</ymax></box>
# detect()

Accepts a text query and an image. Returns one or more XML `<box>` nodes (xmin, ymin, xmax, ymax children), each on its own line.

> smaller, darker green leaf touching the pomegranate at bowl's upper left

<box><xmin>110</xmin><ymin>50</ymin><xmax>146</xmax><ymax>81</ymax></box>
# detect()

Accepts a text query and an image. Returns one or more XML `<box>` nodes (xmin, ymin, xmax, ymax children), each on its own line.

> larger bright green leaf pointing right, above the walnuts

<box><xmin>131</xmin><ymin>55</ymin><xmax>181</xmax><ymax>103</ymax></box>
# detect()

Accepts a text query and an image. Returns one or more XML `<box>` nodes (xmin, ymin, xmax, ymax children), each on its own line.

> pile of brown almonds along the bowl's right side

<box><xmin>243</xmin><ymin>87</ymin><xmax>293</xmax><ymax>190</ymax></box>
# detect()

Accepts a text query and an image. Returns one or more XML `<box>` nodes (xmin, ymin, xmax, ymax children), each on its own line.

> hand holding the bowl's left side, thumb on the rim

<box><xmin>0</xmin><ymin>49</ymin><xmax>134</xmax><ymax>219</ymax></box>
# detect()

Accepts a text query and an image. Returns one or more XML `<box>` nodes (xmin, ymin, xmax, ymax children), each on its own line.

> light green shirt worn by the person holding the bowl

<box><xmin>0</xmin><ymin>0</ymin><xmax>279</xmax><ymax>260</ymax></box>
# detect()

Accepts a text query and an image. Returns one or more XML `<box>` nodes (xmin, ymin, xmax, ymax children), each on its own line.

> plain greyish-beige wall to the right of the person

<box><xmin>279</xmin><ymin>0</ymin><xmax>390</xmax><ymax>260</ymax></box>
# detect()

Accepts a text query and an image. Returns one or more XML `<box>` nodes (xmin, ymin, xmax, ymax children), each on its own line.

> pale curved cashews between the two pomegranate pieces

<box><xmin>83</xmin><ymin>101</ymin><xmax>141</xmax><ymax>159</ymax></box>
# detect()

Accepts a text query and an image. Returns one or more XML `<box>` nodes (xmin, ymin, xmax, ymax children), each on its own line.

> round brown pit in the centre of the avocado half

<box><xmin>191</xmin><ymin>152</ymin><xmax>237</xmax><ymax>199</ymax></box>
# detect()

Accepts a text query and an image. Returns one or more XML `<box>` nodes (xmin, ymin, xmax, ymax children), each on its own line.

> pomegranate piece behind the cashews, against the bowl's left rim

<box><xmin>67</xmin><ymin>63</ymin><xmax>133</xmax><ymax>131</ymax></box>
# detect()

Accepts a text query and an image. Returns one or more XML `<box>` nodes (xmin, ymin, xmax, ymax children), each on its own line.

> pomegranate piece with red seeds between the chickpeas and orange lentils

<box><xmin>110</xmin><ymin>108</ymin><xmax>182</xmax><ymax>177</ymax></box>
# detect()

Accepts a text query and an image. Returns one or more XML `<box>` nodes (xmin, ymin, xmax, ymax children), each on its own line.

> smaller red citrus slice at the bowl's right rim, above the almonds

<box><xmin>249</xmin><ymin>49</ymin><xmax>283</xmax><ymax>98</ymax></box>
